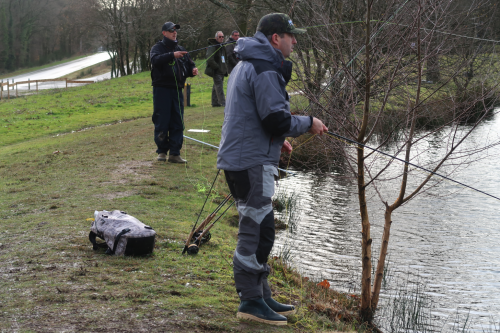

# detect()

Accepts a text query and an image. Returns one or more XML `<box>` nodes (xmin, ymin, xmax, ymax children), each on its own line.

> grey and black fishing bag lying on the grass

<box><xmin>89</xmin><ymin>210</ymin><xmax>156</xmax><ymax>255</ymax></box>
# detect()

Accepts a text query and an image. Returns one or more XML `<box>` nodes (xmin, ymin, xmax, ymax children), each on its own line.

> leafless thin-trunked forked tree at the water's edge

<box><xmin>274</xmin><ymin>0</ymin><xmax>498</xmax><ymax>321</ymax></box>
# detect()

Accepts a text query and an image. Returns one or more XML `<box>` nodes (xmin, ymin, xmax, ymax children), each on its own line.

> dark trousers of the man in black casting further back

<box><xmin>152</xmin><ymin>87</ymin><xmax>184</xmax><ymax>155</ymax></box>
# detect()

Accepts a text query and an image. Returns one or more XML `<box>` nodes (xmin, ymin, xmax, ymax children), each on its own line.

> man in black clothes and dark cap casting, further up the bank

<box><xmin>150</xmin><ymin>22</ymin><xmax>198</xmax><ymax>163</ymax></box>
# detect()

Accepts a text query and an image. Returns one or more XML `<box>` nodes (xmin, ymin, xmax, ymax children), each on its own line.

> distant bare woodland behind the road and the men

<box><xmin>0</xmin><ymin>0</ymin><xmax>500</xmax><ymax>76</ymax></box>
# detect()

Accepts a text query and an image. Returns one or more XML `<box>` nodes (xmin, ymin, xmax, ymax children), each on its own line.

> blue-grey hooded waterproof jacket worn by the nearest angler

<box><xmin>217</xmin><ymin>32</ymin><xmax>312</xmax><ymax>171</ymax></box>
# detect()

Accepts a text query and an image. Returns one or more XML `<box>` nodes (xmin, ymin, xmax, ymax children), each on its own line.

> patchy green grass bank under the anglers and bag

<box><xmin>0</xmin><ymin>69</ymin><xmax>357</xmax><ymax>332</ymax></box>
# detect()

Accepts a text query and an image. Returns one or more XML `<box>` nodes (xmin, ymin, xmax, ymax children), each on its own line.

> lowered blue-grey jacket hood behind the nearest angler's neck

<box><xmin>234</xmin><ymin>31</ymin><xmax>285</xmax><ymax>68</ymax></box>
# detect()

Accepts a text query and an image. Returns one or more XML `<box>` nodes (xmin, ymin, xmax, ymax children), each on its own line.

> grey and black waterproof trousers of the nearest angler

<box><xmin>224</xmin><ymin>165</ymin><xmax>278</xmax><ymax>300</ymax></box>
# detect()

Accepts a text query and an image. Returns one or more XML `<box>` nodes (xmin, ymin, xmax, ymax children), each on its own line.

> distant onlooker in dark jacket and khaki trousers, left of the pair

<box><xmin>205</xmin><ymin>31</ymin><xmax>227</xmax><ymax>107</ymax></box>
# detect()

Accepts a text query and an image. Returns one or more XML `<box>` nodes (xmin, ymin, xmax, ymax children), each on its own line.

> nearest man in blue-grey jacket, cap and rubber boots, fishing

<box><xmin>217</xmin><ymin>13</ymin><xmax>328</xmax><ymax>325</ymax></box>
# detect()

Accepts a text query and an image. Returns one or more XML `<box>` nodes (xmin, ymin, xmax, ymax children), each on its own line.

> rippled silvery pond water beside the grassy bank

<box><xmin>274</xmin><ymin>111</ymin><xmax>500</xmax><ymax>331</ymax></box>
